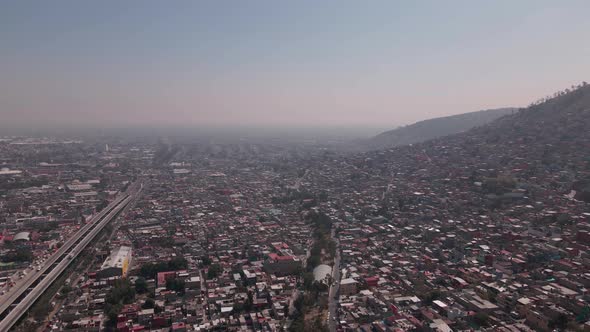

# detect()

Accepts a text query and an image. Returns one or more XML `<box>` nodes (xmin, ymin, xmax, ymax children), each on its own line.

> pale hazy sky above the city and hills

<box><xmin>0</xmin><ymin>0</ymin><xmax>590</xmax><ymax>127</ymax></box>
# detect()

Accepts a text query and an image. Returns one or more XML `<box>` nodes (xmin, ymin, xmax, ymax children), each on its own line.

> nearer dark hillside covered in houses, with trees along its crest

<box><xmin>357</xmin><ymin>84</ymin><xmax>590</xmax><ymax>206</ymax></box>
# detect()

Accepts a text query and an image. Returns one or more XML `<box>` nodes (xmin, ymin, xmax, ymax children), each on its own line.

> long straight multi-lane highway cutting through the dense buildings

<box><xmin>0</xmin><ymin>183</ymin><xmax>142</xmax><ymax>332</ymax></box>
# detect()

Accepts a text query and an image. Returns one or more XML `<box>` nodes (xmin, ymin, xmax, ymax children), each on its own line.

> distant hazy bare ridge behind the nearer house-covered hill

<box><xmin>363</xmin><ymin>108</ymin><xmax>516</xmax><ymax>149</ymax></box>
